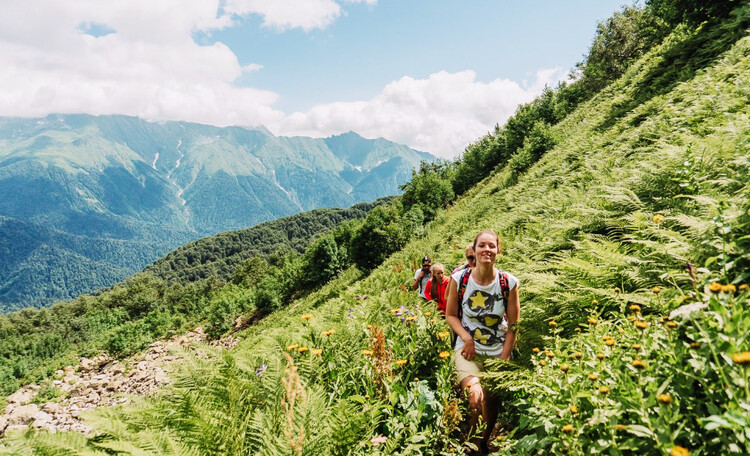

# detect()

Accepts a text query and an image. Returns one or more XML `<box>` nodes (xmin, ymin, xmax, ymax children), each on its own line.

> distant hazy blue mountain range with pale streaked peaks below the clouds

<box><xmin>0</xmin><ymin>114</ymin><xmax>435</xmax><ymax>311</ymax></box>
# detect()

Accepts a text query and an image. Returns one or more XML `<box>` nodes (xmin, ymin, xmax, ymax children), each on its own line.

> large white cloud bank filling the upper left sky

<box><xmin>0</xmin><ymin>0</ymin><xmax>283</xmax><ymax>125</ymax></box>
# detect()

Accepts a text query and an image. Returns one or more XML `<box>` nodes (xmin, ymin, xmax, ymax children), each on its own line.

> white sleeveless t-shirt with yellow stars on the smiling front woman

<box><xmin>451</xmin><ymin>269</ymin><xmax>518</xmax><ymax>357</ymax></box>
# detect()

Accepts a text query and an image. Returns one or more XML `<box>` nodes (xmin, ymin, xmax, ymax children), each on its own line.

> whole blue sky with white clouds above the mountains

<box><xmin>0</xmin><ymin>0</ymin><xmax>625</xmax><ymax>159</ymax></box>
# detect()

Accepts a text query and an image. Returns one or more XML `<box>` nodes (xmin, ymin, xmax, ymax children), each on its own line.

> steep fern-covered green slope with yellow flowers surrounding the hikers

<box><xmin>0</xmin><ymin>0</ymin><xmax>750</xmax><ymax>456</ymax></box>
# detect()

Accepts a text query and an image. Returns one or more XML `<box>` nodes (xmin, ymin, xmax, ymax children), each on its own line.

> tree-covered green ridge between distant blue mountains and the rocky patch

<box><xmin>0</xmin><ymin>198</ymin><xmax>382</xmax><ymax>395</ymax></box>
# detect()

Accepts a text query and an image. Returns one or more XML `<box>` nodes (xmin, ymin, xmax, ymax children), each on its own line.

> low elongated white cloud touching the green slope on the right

<box><xmin>271</xmin><ymin>68</ymin><xmax>565</xmax><ymax>158</ymax></box>
